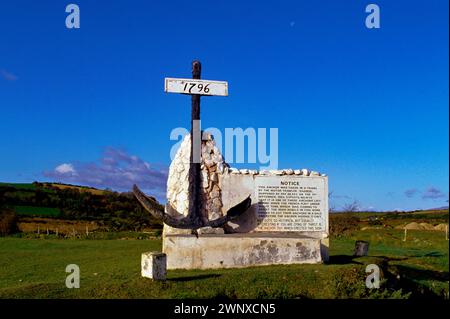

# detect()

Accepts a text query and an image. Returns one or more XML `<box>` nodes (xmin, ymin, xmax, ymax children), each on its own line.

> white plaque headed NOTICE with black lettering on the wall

<box><xmin>255</xmin><ymin>176</ymin><xmax>328</xmax><ymax>233</ymax></box>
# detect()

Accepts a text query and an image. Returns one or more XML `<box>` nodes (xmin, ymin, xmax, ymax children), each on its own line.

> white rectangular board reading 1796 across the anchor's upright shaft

<box><xmin>164</xmin><ymin>78</ymin><xmax>228</xmax><ymax>96</ymax></box>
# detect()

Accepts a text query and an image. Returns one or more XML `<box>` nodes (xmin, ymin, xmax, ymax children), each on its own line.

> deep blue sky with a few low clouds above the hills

<box><xmin>0</xmin><ymin>0</ymin><xmax>449</xmax><ymax>210</ymax></box>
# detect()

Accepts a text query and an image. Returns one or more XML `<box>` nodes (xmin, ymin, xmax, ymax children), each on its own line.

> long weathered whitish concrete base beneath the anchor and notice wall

<box><xmin>163</xmin><ymin>232</ymin><xmax>329</xmax><ymax>269</ymax></box>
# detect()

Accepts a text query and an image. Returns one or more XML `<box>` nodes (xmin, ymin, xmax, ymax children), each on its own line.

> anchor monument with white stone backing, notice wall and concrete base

<box><xmin>133</xmin><ymin>61</ymin><xmax>329</xmax><ymax>269</ymax></box>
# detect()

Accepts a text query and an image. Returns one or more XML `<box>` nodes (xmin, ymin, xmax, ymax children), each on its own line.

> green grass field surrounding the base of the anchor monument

<box><xmin>0</xmin><ymin>229</ymin><xmax>449</xmax><ymax>299</ymax></box>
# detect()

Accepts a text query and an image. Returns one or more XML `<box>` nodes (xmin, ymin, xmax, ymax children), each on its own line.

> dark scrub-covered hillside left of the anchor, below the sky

<box><xmin>0</xmin><ymin>182</ymin><xmax>164</xmax><ymax>230</ymax></box>
